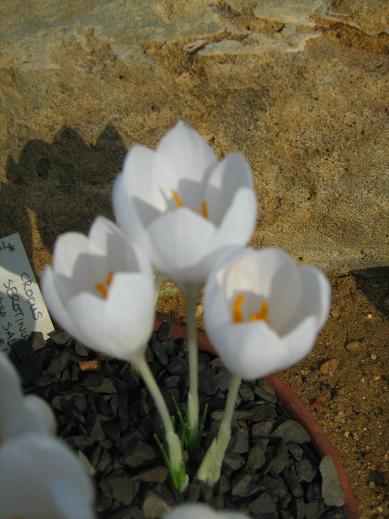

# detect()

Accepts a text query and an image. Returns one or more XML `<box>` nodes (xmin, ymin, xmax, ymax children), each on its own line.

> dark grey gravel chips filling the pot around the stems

<box><xmin>11</xmin><ymin>330</ymin><xmax>346</xmax><ymax>519</ymax></box>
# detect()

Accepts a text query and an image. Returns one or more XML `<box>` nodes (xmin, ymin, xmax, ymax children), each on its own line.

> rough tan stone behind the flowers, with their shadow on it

<box><xmin>0</xmin><ymin>0</ymin><xmax>389</xmax><ymax>273</ymax></box>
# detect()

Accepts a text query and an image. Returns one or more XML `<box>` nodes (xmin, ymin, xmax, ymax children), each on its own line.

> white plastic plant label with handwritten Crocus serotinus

<box><xmin>0</xmin><ymin>233</ymin><xmax>54</xmax><ymax>351</ymax></box>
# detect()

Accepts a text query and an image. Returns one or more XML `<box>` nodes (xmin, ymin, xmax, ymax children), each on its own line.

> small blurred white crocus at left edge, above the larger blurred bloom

<box><xmin>0</xmin><ymin>353</ymin><xmax>56</xmax><ymax>444</ymax></box>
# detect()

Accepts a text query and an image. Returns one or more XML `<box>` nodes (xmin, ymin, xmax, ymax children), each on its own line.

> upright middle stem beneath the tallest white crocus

<box><xmin>185</xmin><ymin>290</ymin><xmax>199</xmax><ymax>446</ymax></box>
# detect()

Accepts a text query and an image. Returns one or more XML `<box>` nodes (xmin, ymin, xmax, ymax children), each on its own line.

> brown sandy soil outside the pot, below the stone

<box><xmin>159</xmin><ymin>268</ymin><xmax>389</xmax><ymax>519</ymax></box>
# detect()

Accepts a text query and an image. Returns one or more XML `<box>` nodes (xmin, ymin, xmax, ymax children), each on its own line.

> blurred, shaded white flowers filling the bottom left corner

<box><xmin>0</xmin><ymin>353</ymin><xmax>95</xmax><ymax>519</ymax></box>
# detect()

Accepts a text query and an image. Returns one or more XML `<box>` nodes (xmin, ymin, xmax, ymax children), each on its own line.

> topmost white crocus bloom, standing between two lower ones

<box><xmin>113</xmin><ymin>122</ymin><xmax>256</xmax><ymax>291</ymax></box>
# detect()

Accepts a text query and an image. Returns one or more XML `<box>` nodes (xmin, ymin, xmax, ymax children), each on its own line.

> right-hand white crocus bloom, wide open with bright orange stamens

<box><xmin>204</xmin><ymin>248</ymin><xmax>330</xmax><ymax>379</ymax></box>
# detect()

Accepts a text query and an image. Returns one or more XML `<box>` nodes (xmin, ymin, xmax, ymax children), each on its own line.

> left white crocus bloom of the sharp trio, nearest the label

<box><xmin>42</xmin><ymin>217</ymin><xmax>156</xmax><ymax>361</ymax></box>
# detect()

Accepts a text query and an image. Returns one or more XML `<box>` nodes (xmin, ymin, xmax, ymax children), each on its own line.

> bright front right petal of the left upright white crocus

<box><xmin>104</xmin><ymin>273</ymin><xmax>156</xmax><ymax>361</ymax></box>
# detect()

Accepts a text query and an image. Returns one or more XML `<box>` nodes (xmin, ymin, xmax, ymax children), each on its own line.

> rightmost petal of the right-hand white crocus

<box><xmin>280</xmin><ymin>266</ymin><xmax>331</xmax><ymax>335</ymax></box>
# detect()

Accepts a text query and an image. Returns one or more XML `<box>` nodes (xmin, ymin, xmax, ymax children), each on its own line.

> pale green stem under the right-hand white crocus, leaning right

<box><xmin>197</xmin><ymin>375</ymin><xmax>241</xmax><ymax>486</ymax></box>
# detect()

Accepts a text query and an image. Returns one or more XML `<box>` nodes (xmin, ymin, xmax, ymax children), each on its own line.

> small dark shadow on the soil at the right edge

<box><xmin>351</xmin><ymin>267</ymin><xmax>389</xmax><ymax>316</ymax></box>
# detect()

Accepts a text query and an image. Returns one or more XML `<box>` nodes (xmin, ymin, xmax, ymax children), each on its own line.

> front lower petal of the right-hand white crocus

<box><xmin>207</xmin><ymin>321</ymin><xmax>288</xmax><ymax>379</ymax></box>
